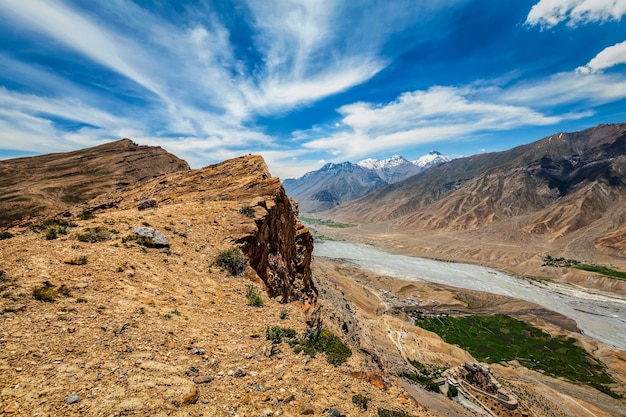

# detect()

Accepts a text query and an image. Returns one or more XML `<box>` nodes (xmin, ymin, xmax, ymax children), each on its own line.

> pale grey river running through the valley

<box><xmin>313</xmin><ymin>240</ymin><xmax>626</xmax><ymax>351</ymax></box>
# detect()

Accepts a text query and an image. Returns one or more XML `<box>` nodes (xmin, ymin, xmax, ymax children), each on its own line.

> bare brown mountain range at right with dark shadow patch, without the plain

<box><xmin>328</xmin><ymin>123</ymin><xmax>626</xmax><ymax>256</ymax></box>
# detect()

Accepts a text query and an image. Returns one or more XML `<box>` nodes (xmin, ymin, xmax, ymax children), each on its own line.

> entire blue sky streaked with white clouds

<box><xmin>0</xmin><ymin>0</ymin><xmax>626</xmax><ymax>178</ymax></box>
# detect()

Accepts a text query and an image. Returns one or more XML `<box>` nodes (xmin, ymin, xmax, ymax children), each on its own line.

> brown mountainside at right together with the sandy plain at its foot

<box><xmin>321</xmin><ymin>124</ymin><xmax>626</xmax><ymax>286</ymax></box>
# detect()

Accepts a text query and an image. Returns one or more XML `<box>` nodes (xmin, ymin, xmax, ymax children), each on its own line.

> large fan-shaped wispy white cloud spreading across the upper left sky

<box><xmin>0</xmin><ymin>0</ymin><xmax>385</xmax><ymax>159</ymax></box>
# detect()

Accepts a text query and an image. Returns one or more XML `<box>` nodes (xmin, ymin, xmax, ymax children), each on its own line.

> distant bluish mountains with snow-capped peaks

<box><xmin>283</xmin><ymin>151</ymin><xmax>450</xmax><ymax>213</ymax></box>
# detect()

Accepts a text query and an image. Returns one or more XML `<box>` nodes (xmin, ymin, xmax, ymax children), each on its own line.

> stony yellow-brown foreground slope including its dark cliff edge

<box><xmin>0</xmin><ymin>156</ymin><xmax>432</xmax><ymax>416</ymax></box>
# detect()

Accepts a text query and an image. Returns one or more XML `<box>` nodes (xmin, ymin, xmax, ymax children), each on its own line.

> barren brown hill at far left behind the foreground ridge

<box><xmin>0</xmin><ymin>139</ymin><xmax>189</xmax><ymax>226</ymax></box>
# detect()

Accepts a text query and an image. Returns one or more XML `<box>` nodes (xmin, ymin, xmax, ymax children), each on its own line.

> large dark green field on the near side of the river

<box><xmin>415</xmin><ymin>314</ymin><xmax>619</xmax><ymax>398</ymax></box>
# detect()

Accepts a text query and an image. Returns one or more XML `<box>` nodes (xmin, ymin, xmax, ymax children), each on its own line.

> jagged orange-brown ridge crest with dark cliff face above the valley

<box><xmin>67</xmin><ymin>155</ymin><xmax>317</xmax><ymax>306</ymax></box>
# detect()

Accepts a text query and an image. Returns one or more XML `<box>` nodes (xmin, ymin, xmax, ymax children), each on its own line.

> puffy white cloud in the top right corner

<box><xmin>526</xmin><ymin>0</ymin><xmax>626</xmax><ymax>29</ymax></box>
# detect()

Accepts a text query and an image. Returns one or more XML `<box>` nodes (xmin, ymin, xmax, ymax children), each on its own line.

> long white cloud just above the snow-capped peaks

<box><xmin>303</xmin><ymin>86</ymin><xmax>583</xmax><ymax>159</ymax></box>
